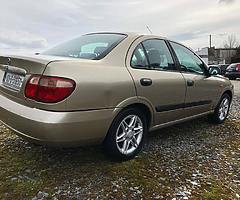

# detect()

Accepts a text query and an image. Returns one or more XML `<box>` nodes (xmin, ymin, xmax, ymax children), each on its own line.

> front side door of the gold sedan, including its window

<box><xmin>170</xmin><ymin>42</ymin><xmax>219</xmax><ymax>117</ymax></box>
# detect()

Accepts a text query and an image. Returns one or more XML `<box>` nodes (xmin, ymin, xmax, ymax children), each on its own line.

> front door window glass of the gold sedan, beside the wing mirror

<box><xmin>170</xmin><ymin>42</ymin><xmax>205</xmax><ymax>74</ymax></box>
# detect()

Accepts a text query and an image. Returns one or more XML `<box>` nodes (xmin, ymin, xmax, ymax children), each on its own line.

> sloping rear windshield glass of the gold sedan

<box><xmin>42</xmin><ymin>34</ymin><xmax>126</xmax><ymax>60</ymax></box>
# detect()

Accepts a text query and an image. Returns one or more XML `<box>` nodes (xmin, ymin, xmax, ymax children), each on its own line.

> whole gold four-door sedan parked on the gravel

<box><xmin>0</xmin><ymin>33</ymin><xmax>233</xmax><ymax>159</ymax></box>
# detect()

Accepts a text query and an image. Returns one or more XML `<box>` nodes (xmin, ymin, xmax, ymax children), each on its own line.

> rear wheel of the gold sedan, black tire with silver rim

<box><xmin>103</xmin><ymin>108</ymin><xmax>147</xmax><ymax>161</ymax></box>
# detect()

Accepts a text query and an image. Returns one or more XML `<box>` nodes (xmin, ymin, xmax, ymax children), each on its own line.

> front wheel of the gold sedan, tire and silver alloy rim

<box><xmin>209</xmin><ymin>94</ymin><xmax>231</xmax><ymax>124</ymax></box>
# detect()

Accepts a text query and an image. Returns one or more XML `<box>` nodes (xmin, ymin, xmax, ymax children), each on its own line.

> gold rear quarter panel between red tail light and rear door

<box><xmin>44</xmin><ymin>60</ymin><xmax>136</xmax><ymax>111</ymax></box>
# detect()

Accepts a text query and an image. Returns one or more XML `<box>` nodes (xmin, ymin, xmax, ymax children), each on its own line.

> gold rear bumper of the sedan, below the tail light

<box><xmin>0</xmin><ymin>95</ymin><xmax>114</xmax><ymax>147</ymax></box>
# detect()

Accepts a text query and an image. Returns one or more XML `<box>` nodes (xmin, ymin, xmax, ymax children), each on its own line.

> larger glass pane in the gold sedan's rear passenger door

<box><xmin>143</xmin><ymin>39</ymin><xmax>176</xmax><ymax>70</ymax></box>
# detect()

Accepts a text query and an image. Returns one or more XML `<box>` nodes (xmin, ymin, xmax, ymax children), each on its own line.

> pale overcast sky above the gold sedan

<box><xmin>0</xmin><ymin>0</ymin><xmax>240</xmax><ymax>51</ymax></box>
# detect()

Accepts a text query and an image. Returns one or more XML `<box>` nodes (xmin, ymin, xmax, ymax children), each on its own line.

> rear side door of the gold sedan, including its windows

<box><xmin>127</xmin><ymin>37</ymin><xmax>186</xmax><ymax>125</ymax></box>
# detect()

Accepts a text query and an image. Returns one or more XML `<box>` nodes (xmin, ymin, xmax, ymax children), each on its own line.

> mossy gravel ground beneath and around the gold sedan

<box><xmin>0</xmin><ymin>81</ymin><xmax>240</xmax><ymax>200</ymax></box>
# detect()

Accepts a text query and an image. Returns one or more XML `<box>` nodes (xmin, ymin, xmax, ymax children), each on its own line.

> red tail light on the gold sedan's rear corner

<box><xmin>25</xmin><ymin>75</ymin><xmax>76</xmax><ymax>103</ymax></box>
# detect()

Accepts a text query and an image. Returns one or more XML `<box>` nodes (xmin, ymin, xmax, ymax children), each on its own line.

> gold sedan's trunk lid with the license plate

<box><xmin>0</xmin><ymin>55</ymin><xmax>76</xmax><ymax>107</ymax></box>
